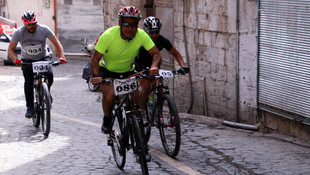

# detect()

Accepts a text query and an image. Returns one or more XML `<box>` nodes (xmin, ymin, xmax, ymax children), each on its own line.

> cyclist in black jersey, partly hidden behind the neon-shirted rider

<box><xmin>135</xmin><ymin>16</ymin><xmax>189</xmax><ymax>115</ymax></box>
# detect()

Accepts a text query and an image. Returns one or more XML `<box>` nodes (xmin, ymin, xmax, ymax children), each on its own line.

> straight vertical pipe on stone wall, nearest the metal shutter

<box><xmin>236</xmin><ymin>0</ymin><xmax>240</xmax><ymax>122</ymax></box>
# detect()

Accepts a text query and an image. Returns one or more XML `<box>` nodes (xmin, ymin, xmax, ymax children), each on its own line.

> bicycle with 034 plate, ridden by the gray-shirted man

<box><xmin>21</xmin><ymin>61</ymin><xmax>60</xmax><ymax>137</ymax></box>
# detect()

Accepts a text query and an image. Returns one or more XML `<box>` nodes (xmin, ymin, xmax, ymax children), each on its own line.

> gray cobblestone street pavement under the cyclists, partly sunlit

<box><xmin>0</xmin><ymin>60</ymin><xmax>310</xmax><ymax>175</ymax></box>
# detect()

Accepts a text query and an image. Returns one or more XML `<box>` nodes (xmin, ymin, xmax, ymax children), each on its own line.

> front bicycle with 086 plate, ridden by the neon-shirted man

<box><xmin>95</xmin><ymin>75</ymin><xmax>148</xmax><ymax>175</ymax></box>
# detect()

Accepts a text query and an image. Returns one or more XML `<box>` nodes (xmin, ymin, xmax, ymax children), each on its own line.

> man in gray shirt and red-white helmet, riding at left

<box><xmin>8</xmin><ymin>11</ymin><xmax>66</xmax><ymax>118</ymax></box>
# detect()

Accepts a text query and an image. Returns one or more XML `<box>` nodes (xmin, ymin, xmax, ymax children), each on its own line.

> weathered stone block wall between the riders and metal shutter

<box><xmin>104</xmin><ymin>0</ymin><xmax>258</xmax><ymax>123</ymax></box>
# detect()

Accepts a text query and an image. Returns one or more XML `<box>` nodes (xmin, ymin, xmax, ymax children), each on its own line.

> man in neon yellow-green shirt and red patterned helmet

<box><xmin>90</xmin><ymin>6</ymin><xmax>162</xmax><ymax>160</ymax></box>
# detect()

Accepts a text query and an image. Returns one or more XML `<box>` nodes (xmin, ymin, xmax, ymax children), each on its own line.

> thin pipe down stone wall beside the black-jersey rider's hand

<box><xmin>183</xmin><ymin>0</ymin><xmax>194</xmax><ymax>113</ymax></box>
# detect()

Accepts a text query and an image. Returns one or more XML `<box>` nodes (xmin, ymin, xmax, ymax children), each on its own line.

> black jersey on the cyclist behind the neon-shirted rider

<box><xmin>135</xmin><ymin>35</ymin><xmax>173</xmax><ymax>71</ymax></box>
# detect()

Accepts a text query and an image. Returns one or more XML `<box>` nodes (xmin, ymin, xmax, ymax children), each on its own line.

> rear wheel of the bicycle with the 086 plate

<box><xmin>109</xmin><ymin>107</ymin><xmax>126</xmax><ymax>169</ymax></box>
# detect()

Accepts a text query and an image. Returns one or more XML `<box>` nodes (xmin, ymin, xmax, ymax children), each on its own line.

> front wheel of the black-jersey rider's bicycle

<box><xmin>158</xmin><ymin>94</ymin><xmax>181</xmax><ymax>158</ymax></box>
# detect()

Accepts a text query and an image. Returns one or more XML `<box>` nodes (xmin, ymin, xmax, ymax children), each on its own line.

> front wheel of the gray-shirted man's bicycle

<box><xmin>40</xmin><ymin>82</ymin><xmax>51</xmax><ymax>136</ymax></box>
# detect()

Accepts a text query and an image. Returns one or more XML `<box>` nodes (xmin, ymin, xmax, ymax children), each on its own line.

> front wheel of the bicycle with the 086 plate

<box><xmin>132</xmin><ymin>115</ymin><xmax>149</xmax><ymax>175</ymax></box>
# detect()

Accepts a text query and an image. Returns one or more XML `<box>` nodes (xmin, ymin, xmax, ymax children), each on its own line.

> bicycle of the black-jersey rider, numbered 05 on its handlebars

<box><xmin>145</xmin><ymin>69</ymin><xmax>186</xmax><ymax>158</ymax></box>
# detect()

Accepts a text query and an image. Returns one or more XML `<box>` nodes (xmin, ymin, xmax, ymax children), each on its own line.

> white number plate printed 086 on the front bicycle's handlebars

<box><xmin>114</xmin><ymin>77</ymin><xmax>138</xmax><ymax>96</ymax></box>
